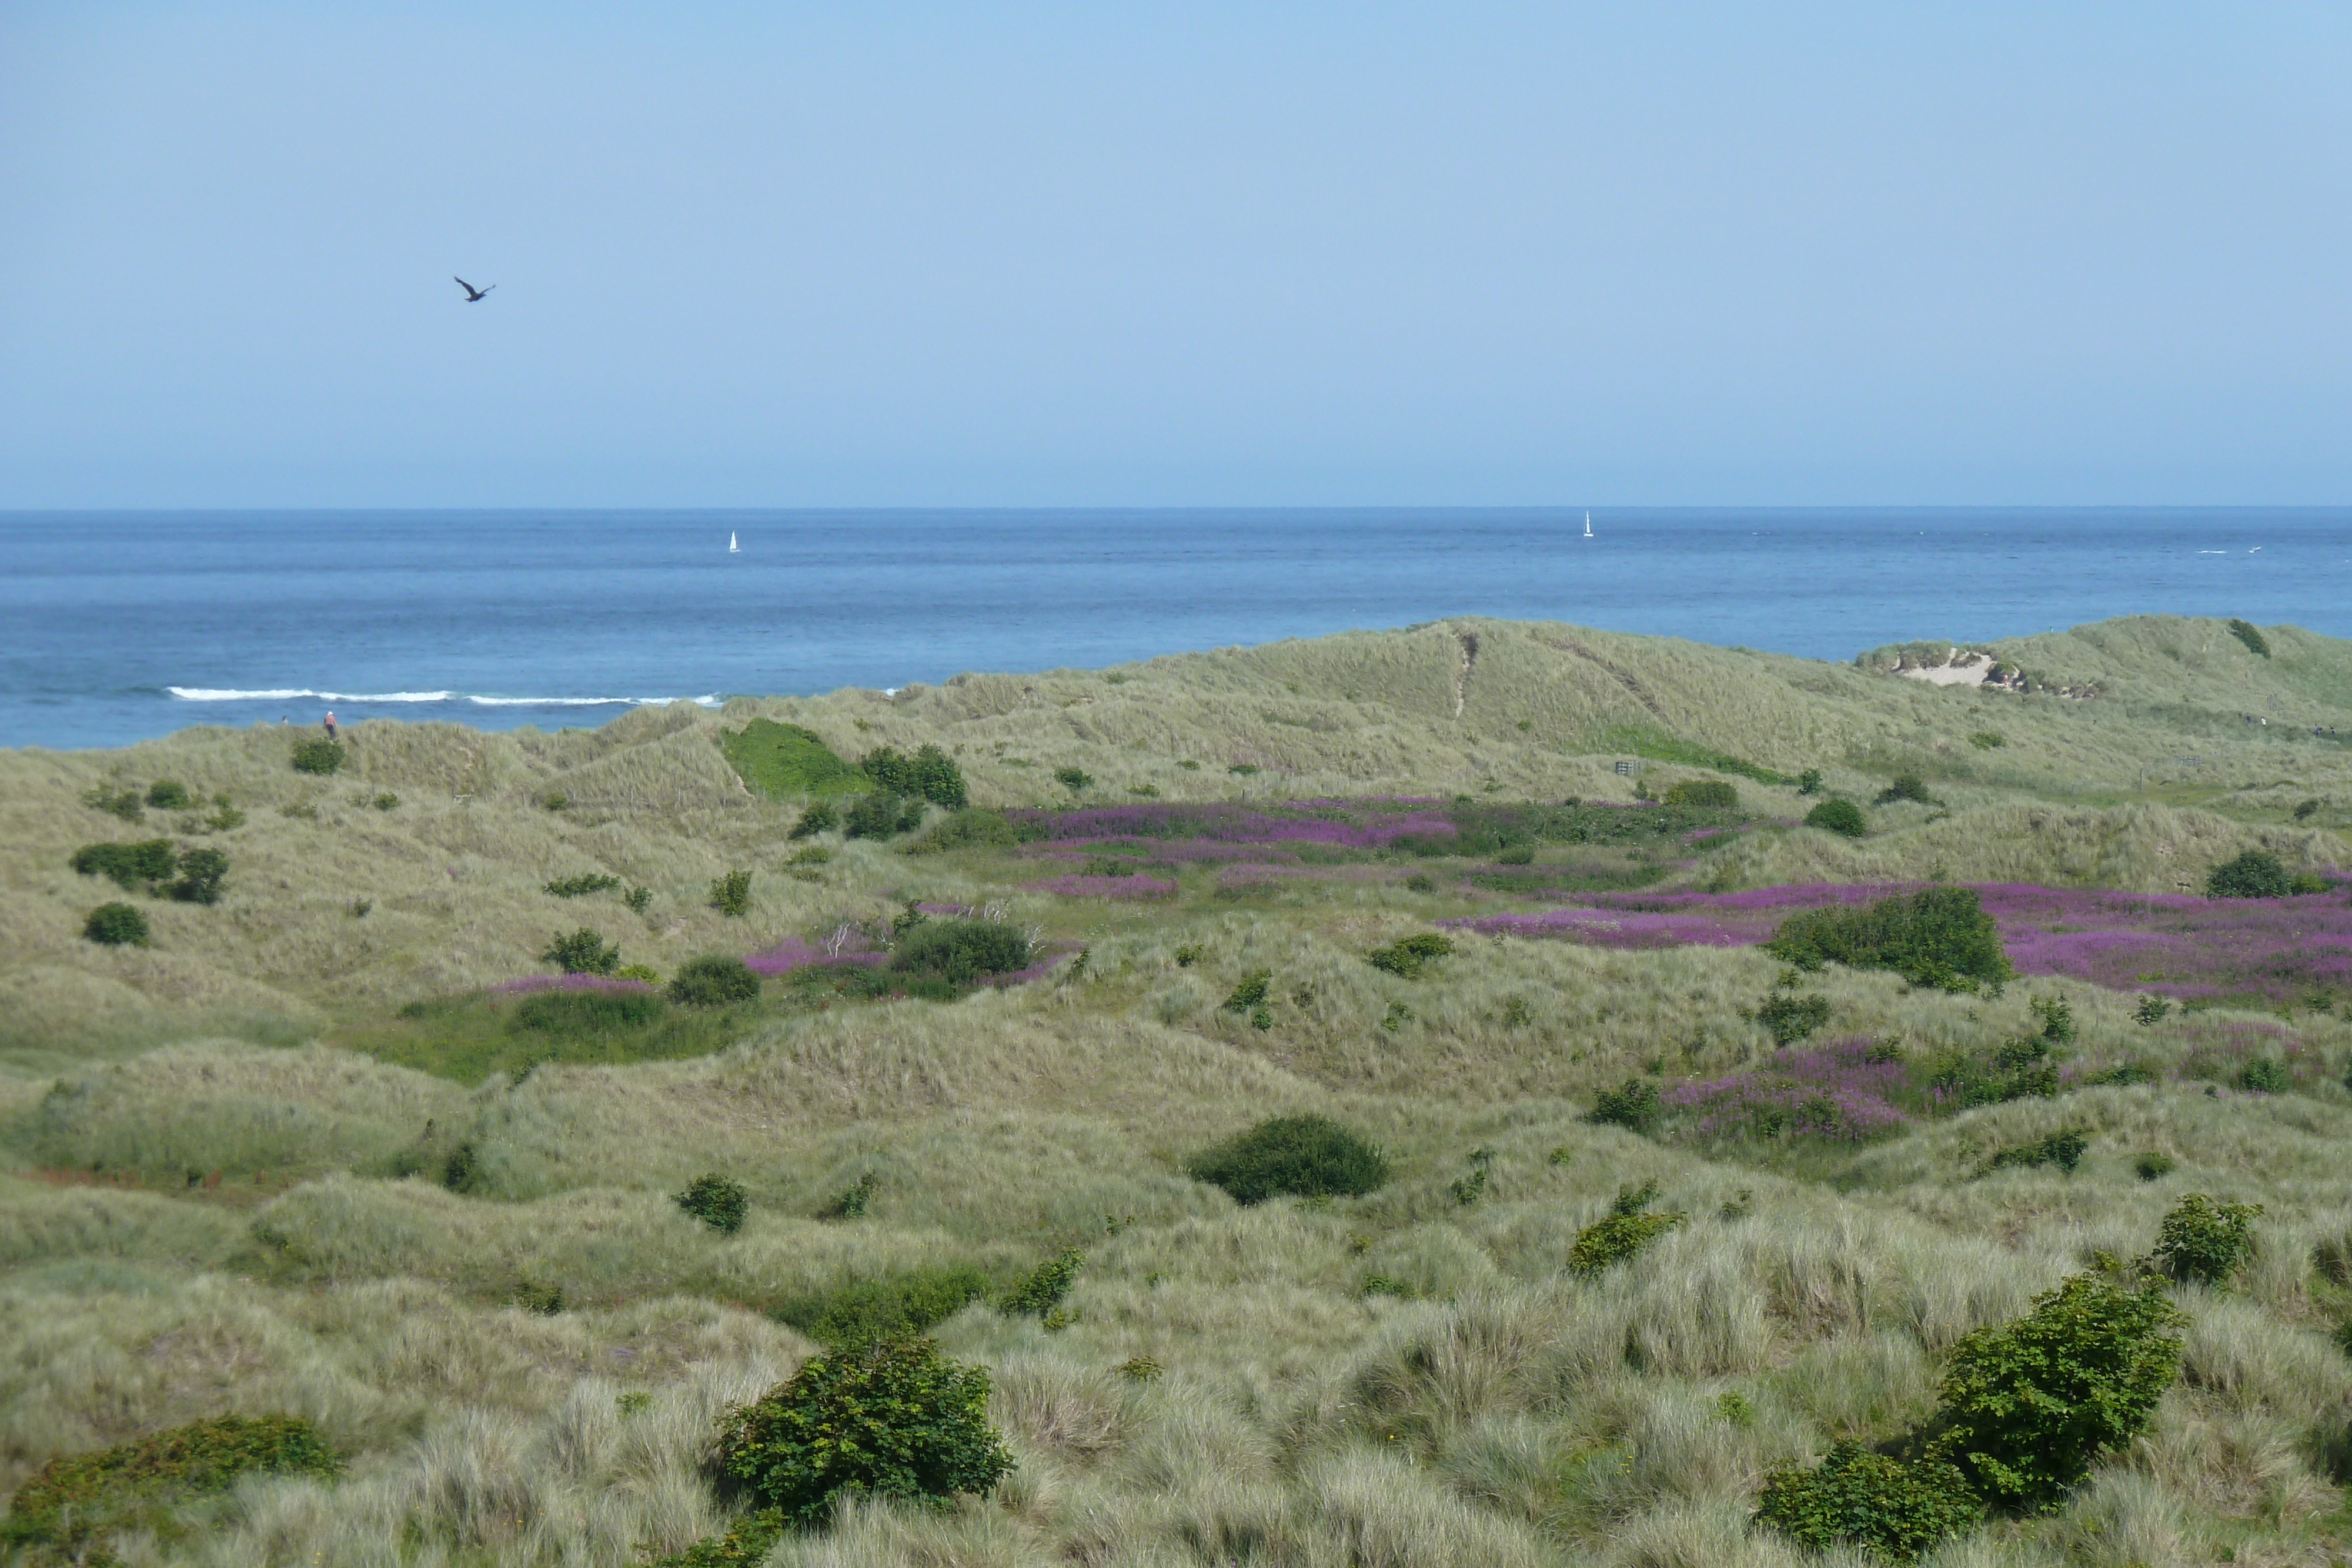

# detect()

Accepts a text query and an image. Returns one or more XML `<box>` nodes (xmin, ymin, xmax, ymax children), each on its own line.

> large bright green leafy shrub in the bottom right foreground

<box><xmin>1931</xmin><ymin>1274</ymin><xmax>2187</xmax><ymax>1507</ymax></box>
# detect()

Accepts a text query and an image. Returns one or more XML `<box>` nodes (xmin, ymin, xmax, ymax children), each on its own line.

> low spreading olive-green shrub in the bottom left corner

<box><xmin>0</xmin><ymin>1415</ymin><xmax>343</xmax><ymax>1563</ymax></box>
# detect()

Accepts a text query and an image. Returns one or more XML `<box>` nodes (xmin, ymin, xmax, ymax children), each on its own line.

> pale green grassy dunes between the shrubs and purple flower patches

<box><xmin>0</xmin><ymin>616</ymin><xmax>2352</xmax><ymax>1568</ymax></box>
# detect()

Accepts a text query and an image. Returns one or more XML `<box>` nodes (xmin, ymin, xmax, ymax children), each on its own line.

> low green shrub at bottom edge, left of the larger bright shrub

<box><xmin>1755</xmin><ymin>1443</ymin><xmax>1985</xmax><ymax>1563</ymax></box>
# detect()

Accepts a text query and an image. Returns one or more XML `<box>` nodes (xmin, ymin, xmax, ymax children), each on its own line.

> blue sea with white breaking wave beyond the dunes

<box><xmin>0</xmin><ymin>508</ymin><xmax>2352</xmax><ymax>748</ymax></box>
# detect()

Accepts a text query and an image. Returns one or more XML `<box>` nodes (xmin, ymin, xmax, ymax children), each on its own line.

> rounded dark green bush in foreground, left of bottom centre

<box><xmin>717</xmin><ymin>1338</ymin><xmax>1014</xmax><ymax>1526</ymax></box>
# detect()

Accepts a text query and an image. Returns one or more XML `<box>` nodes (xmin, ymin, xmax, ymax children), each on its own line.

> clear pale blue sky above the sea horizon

<box><xmin>0</xmin><ymin>0</ymin><xmax>2352</xmax><ymax>508</ymax></box>
